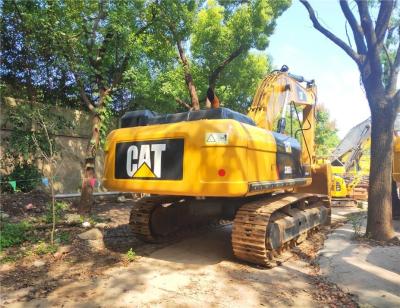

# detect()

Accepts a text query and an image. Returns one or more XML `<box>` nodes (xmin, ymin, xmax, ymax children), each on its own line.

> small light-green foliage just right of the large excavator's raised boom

<box><xmin>315</xmin><ymin>106</ymin><xmax>339</xmax><ymax>156</ymax></box>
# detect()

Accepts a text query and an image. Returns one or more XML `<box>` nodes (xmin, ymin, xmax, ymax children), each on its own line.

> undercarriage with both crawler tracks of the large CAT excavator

<box><xmin>130</xmin><ymin>193</ymin><xmax>330</xmax><ymax>267</ymax></box>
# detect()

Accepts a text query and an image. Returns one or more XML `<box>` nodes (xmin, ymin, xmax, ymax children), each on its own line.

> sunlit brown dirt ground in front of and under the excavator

<box><xmin>0</xmin><ymin>192</ymin><xmax>357</xmax><ymax>307</ymax></box>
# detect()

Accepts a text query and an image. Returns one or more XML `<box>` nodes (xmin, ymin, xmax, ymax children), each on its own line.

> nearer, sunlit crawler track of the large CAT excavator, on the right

<box><xmin>232</xmin><ymin>193</ymin><xmax>330</xmax><ymax>267</ymax></box>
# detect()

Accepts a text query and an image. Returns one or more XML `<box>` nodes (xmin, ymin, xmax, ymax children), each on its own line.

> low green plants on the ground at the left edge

<box><xmin>0</xmin><ymin>221</ymin><xmax>32</xmax><ymax>251</ymax></box>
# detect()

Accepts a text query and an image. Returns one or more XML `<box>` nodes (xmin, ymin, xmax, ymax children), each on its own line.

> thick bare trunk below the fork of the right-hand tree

<box><xmin>367</xmin><ymin>102</ymin><xmax>396</xmax><ymax>241</ymax></box>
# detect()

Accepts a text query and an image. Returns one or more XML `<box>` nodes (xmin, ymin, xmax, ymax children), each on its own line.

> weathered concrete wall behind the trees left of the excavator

<box><xmin>0</xmin><ymin>98</ymin><xmax>109</xmax><ymax>193</ymax></box>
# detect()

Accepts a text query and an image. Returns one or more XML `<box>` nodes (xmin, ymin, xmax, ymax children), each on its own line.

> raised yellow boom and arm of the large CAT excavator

<box><xmin>248</xmin><ymin>65</ymin><xmax>332</xmax><ymax>196</ymax></box>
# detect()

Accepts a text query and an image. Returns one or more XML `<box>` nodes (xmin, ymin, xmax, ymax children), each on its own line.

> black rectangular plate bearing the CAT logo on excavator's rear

<box><xmin>115</xmin><ymin>138</ymin><xmax>184</xmax><ymax>180</ymax></box>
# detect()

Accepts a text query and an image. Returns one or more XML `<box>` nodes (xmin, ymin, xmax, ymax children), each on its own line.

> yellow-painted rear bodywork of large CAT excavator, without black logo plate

<box><xmin>103</xmin><ymin>119</ymin><xmax>311</xmax><ymax>197</ymax></box>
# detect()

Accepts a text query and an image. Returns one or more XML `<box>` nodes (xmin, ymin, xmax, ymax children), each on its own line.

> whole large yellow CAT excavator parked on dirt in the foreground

<box><xmin>103</xmin><ymin>66</ymin><xmax>331</xmax><ymax>267</ymax></box>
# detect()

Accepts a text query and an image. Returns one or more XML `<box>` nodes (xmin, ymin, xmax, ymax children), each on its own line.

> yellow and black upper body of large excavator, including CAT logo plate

<box><xmin>103</xmin><ymin>119</ymin><xmax>311</xmax><ymax>197</ymax></box>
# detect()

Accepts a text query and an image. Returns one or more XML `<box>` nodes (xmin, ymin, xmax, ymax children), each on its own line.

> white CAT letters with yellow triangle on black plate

<box><xmin>126</xmin><ymin>144</ymin><xmax>166</xmax><ymax>178</ymax></box>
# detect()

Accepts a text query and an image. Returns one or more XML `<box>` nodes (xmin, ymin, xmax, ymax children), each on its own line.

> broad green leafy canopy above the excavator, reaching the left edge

<box><xmin>2</xmin><ymin>0</ymin><xmax>290</xmax><ymax>118</ymax></box>
